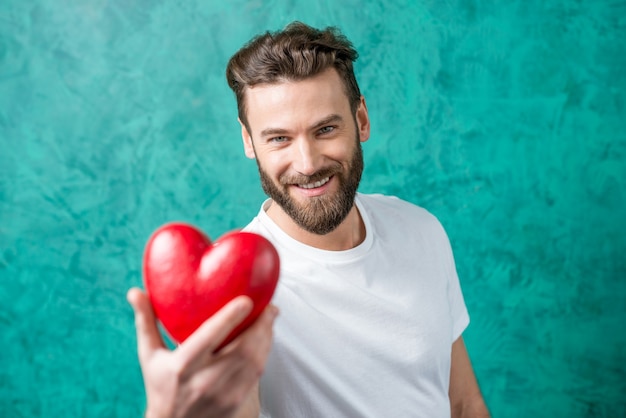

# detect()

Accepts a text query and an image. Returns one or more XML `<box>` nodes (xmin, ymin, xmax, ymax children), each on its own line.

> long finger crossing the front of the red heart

<box><xmin>177</xmin><ymin>296</ymin><xmax>253</xmax><ymax>361</ymax></box>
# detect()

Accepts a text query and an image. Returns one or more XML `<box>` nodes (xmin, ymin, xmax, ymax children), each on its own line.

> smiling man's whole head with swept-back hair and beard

<box><xmin>227</xmin><ymin>23</ymin><xmax>369</xmax><ymax>235</ymax></box>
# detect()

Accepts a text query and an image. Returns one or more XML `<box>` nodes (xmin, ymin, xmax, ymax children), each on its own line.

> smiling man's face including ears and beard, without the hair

<box><xmin>242</xmin><ymin>69</ymin><xmax>369</xmax><ymax>235</ymax></box>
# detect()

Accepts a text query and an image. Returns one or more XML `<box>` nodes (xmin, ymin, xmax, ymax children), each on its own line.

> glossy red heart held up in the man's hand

<box><xmin>143</xmin><ymin>223</ymin><xmax>280</xmax><ymax>349</ymax></box>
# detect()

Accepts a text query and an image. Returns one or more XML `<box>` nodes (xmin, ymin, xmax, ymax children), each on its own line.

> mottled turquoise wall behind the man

<box><xmin>0</xmin><ymin>0</ymin><xmax>626</xmax><ymax>418</ymax></box>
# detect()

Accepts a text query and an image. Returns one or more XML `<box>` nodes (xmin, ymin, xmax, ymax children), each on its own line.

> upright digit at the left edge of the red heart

<box><xmin>126</xmin><ymin>287</ymin><xmax>165</xmax><ymax>364</ymax></box>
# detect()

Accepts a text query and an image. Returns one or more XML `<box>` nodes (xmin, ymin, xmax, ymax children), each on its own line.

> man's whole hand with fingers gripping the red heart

<box><xmin>127</xmin><ymin>288</ymin><xmax>278</xmax><ymax>417</ymax></box>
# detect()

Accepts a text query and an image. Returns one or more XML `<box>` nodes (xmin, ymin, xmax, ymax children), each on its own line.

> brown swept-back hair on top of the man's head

<box><xmin>226</xmin><ymin>22</ymin><xmax>361</xmax><ymax>132</ymax></box>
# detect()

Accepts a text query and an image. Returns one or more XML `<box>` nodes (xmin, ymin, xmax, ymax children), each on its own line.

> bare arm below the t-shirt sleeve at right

<box><xmin>449</xmin><ymin>337</ymin><xmax>491</xmax><ymax>418</ymax></box>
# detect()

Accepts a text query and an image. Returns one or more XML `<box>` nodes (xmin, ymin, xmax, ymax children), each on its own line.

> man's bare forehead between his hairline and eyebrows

<box><xmin>245</xmin><ymin>68</ymin><xmax>350</xmax><ymax>131</ymax></box>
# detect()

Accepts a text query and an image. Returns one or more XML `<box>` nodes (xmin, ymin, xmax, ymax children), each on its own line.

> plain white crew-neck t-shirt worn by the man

<box><xmin>246</xmin><ymin>194</ymin><xmax>469</xmax><ymax>418</ymax></box>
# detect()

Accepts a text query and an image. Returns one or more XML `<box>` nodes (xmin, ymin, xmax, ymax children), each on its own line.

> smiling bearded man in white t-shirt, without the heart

<box><xmin>128</xmin><ymin>23</ymin><xmax>489</xmax><ymax>418</ymax></box>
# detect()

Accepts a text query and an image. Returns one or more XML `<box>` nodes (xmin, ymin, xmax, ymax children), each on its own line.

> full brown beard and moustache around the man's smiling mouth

<box><xmin>257</xmin><ymin>132</ymin><xmax>364</xmax><ymax>235</ymax></box>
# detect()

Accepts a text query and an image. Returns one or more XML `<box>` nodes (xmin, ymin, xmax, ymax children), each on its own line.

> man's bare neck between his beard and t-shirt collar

<box><xmin>267</xmin><ymin>201</ymin><xmax>365</xmax><ymax>251</ymax></box>
